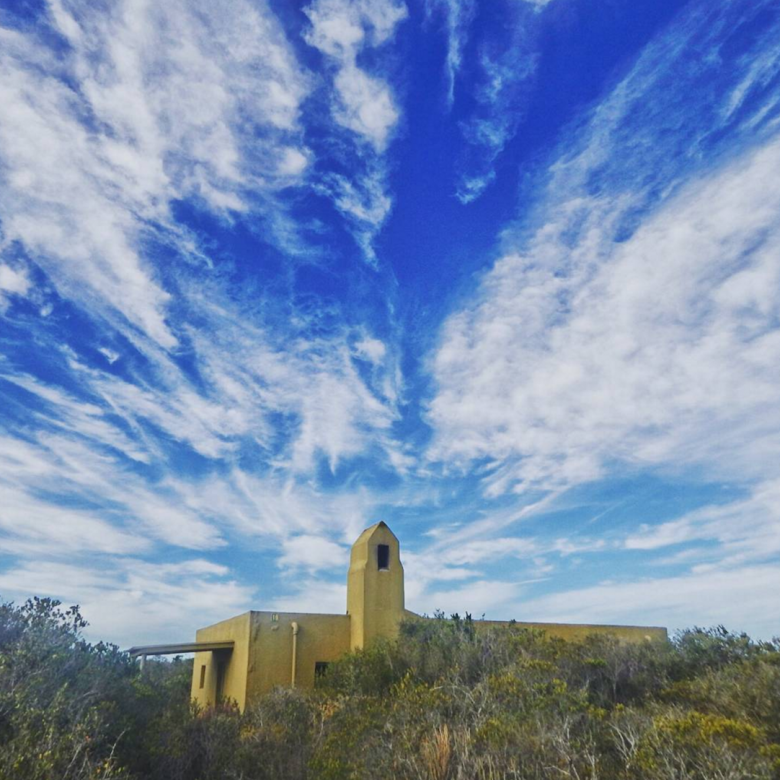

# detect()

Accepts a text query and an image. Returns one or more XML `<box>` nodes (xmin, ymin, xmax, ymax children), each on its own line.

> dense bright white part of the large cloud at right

<box><xmin>431</xmin><ymin>133</ymin><xmax>780</xmax><ymax>494</ymax></box>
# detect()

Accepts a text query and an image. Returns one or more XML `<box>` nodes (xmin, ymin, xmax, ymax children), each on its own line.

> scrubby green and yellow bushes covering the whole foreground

<box><xmin>0</xmin><ymin>599</ymin><xmax>780</xmax><ymax>780</ymax></box>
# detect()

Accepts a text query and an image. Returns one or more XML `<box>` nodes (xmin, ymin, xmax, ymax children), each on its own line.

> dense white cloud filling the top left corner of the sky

<box><xmin>0</xmin><ymin>2</ymin><xmax>308</xmax><ymax>348</ymax></box>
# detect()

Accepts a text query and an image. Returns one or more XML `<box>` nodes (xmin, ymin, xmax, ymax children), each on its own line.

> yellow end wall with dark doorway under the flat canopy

<box><xmin>192</xmin><ymin>612</ymin><xmax>251</xmax><ymax>709</ymax></box>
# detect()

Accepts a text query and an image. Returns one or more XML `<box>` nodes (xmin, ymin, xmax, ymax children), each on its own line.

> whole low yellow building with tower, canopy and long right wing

<box><xmin>130</xmin><ymin>523</ymin><xmax>666</xmax><ymax>710</ymax></box>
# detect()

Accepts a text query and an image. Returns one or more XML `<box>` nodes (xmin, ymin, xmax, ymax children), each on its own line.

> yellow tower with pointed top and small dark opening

<box><xmin>347</xmin><ymin>523</ymin><xmax>404</xmax><ymax>650</ymax></box>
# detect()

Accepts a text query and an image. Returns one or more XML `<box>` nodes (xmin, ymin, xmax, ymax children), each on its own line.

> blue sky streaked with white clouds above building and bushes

<box><xmin>0</xmin><ymin>0</ymin><xmax>780</xmax><ymax>647</ymax></box>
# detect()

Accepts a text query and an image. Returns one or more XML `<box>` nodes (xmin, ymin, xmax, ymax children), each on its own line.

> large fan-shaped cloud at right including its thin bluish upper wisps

<box><xmin>430</xmin><ymin>0</ymin><xmax>780</xmax><ymax>492</ymax></box>
